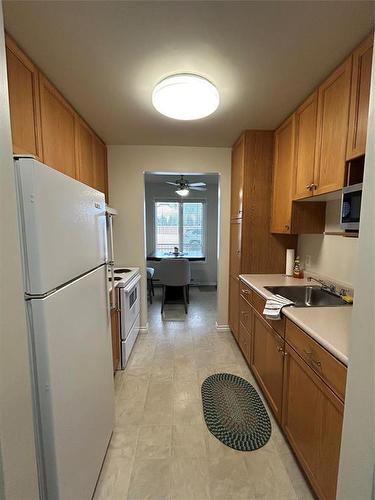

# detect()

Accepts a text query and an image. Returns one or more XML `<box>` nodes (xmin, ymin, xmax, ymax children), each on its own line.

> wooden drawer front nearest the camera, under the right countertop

<box><xmin>285</xmin><ymin>319</ymin><xmax>347</xmax><ymax>401</ymax></box>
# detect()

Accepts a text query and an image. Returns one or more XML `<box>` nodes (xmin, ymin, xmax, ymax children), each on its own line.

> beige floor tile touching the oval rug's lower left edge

<box><xmin>172</xmin><ymin>424</ymin><xmax>207</xmax><ymax>458</ymax></box>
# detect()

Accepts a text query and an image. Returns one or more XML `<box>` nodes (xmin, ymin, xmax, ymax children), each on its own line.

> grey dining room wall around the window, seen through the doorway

<box><xmin>145</xmin><ymin>176</ymin><xmax>218</xmax><ymax>285</ymax></box>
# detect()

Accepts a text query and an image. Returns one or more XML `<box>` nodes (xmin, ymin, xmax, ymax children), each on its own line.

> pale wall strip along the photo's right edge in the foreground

<box><xmin>337</xmin><ymin>33</ymin><xmax>375</xmax><ymax>500</ymax></box>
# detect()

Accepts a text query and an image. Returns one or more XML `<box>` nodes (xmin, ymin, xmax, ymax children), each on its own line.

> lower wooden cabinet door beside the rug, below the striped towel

<box><xmin>251</xmin><ymin>312</ymin><xmax>284</xmax><ymax>421</ymax></box>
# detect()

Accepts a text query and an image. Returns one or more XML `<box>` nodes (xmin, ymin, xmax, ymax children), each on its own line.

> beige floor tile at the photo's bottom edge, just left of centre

<box><xmin>127</xmin><ymin>458</ymin><xmax>171</xmax><ymax>500</ymax></box>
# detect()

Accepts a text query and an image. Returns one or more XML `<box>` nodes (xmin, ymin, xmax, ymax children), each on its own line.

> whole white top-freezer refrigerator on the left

<box><xmin>15</xmin><ymin>157</ymin><xmax>114</xmax><ymax>500</ymax></box>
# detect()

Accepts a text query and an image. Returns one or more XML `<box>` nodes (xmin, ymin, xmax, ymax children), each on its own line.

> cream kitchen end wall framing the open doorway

<box><xmin>108</xmin><ymin>146</ymin><xmax>231</xmax><ymax>326</ymax></box>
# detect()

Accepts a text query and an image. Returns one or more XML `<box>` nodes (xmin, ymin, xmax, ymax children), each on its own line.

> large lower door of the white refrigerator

<box><xmin>27</xmin><ymin>266</ymin><xmax>114</xmax><ymax>500</ymax></box>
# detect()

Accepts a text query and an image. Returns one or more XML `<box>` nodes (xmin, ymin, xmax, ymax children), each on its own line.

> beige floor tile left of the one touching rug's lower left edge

<box><xmin>136</xmin><ymin>425</ymin><xmax>172</xmax><ymax>459</ymax></box>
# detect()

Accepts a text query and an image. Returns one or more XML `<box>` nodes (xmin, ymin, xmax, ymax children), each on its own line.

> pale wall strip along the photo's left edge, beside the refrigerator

<box><xmin>0</xmin><ymin>5</ymin><xmax>39</xmax><ymax>500</ymax></box>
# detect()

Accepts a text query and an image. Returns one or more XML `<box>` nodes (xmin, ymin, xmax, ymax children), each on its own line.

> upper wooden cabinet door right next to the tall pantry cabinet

<box><xmin>271</xmin><ymin>115</ymin><xmax>295</xmax><ymax>233</ymax></box>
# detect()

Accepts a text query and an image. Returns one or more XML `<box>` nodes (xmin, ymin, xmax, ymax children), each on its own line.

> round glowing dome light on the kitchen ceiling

<box><xmin>152</xmin><ymin>74</ymin><xmax>220</xmax><ymax>120</ymax></box>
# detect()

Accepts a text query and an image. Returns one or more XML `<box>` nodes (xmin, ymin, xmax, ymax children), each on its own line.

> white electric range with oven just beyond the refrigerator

<box><xmin>115</xmin><ymin>267</ymin><xmax>141</xmax><ymax>370</ymax></box>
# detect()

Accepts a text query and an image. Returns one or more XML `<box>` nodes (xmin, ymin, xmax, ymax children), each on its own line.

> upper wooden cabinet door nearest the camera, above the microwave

<box><xmin>346</xmin><ymin>33</ymin><xmax>374</xmax><ymax>160</ymax></box>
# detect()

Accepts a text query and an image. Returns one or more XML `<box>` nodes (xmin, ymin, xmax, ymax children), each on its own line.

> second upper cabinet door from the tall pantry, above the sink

<box><xmin>293</xmin><ymin>92</ymin><xmax>318</xmax><ymax>200</ymax></box>
